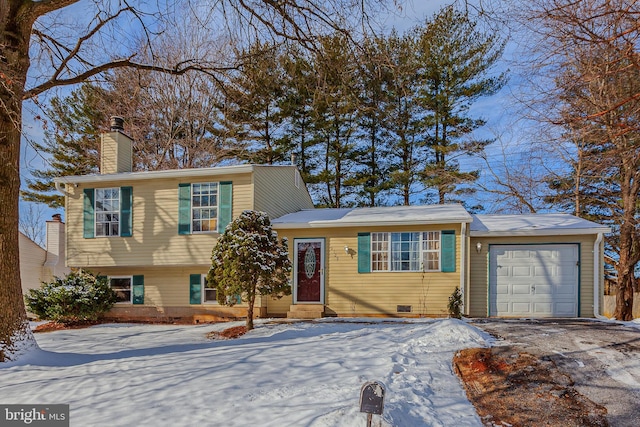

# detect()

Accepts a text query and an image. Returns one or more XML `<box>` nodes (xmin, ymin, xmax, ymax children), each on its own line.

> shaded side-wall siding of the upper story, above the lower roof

<box><xmin>254</xmin><ymin>166</ymin><xmax>313</xmax><ymax>219</ymax></box>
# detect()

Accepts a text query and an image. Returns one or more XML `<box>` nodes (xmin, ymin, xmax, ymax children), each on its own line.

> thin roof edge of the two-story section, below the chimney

<box><xmin>54</xmin><ymin>165</ymin><xmax>295</xmax><ymax>184</ymax></box>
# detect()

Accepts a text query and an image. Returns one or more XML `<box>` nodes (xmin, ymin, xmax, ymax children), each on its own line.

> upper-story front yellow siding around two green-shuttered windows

<box><xmin>67</xmin><ymin>174</ymin><xmax>253</xmax><ymax>267</ymax></box>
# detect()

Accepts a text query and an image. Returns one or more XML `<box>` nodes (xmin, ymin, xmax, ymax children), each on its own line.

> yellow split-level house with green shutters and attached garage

<box><xmin>56</xmin><ymin>120</ymin><xmax>609</xmax><ymax>322</ymax></box>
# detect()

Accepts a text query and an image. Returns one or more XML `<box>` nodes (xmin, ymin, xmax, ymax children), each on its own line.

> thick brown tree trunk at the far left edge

<box><xmin>0</xmin><ymin>2</ymin><xmax>35</xmax><ymax>362</ymax></box>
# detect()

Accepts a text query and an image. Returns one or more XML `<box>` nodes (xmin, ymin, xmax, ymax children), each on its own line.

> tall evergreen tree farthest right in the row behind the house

<box><xmin>418</xmin><ymin>6</ymin><xmax>506</xmax><ymax>203</ymax></box>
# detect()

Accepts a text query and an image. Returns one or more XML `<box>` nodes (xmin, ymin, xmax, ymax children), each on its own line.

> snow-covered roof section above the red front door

<box><xmin>271</xmin><ymin>204</ymin><xmax>472</xmax><ymax>229</ymax></box>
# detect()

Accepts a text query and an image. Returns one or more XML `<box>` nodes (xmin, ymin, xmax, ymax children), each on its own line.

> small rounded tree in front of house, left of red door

<box><xmin>207</xmin><ymin>210</ymin><xmax>291</xmax><ymax>330</ymax></box>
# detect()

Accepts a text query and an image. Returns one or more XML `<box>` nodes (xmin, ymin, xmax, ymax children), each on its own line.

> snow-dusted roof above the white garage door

<box><xmin>470</xmin><ymin>213</ymin><xmax>611</xmax><ymax>237</ymax></box>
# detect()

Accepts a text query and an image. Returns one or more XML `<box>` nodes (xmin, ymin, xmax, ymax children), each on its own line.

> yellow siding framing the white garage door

<box><xmin>467</xmin><ymin>235</ymin><xmax>596</xmax><ymax>317</ymax></box>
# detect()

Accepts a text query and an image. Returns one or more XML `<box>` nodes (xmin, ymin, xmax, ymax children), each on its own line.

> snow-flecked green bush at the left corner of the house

<box><xmin>24</xmin><ymin>270</ymin><xmax>116</xmax><ymax>324</ymax></box>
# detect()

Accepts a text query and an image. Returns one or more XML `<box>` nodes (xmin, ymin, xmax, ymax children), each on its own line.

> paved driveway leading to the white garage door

<box><xmin>471</xmin><ymin>319</ymin><xmax>640</xmax><ymax>427</ymax></box>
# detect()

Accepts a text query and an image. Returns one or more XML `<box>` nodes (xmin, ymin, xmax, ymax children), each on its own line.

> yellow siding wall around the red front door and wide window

<box><xmin>267</xmin><ymin>224</ymin><xmax>460</xmax><ymax>316</ymax></box>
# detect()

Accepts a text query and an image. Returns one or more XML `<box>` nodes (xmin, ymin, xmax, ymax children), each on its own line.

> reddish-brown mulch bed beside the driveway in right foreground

<box><xmin>453</xmin><ymin>347</ymin><xmax>608</xmax><ymax>427</ymax></box>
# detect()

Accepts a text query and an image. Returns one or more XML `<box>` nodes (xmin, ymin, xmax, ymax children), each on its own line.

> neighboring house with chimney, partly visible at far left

<box><xmin>18</xmin><ymin>214</ymin><xmax>70</xmax><ymax>294</ymax></box>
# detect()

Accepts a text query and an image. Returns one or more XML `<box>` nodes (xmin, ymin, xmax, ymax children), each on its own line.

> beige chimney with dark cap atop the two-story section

<box><xmin>100</xmin><ymin>116</ymin><xmax>133</xmax><ymax>174</ymax></box>
